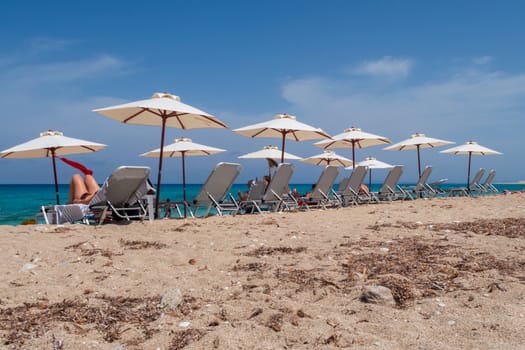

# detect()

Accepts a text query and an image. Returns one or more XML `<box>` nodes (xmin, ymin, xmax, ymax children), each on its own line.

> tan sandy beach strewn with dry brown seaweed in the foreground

<box><xmin>0</xmin><ymin>194</ymin><xmax>525</xmax><ymax>350</ymax></box>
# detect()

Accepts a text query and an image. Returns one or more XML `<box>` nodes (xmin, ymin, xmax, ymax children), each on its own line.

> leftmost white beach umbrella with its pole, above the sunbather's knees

<box><xmin>0</xmin><ymin>130</ymin><xmax>106</xmax><ymax>204</ymax></box>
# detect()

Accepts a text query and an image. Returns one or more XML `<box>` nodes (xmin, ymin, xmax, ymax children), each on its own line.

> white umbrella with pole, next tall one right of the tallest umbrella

<box><xmin>233</xmin><ymin>114</ymin><xmax>330</xmax><ymax>163</ymax></box>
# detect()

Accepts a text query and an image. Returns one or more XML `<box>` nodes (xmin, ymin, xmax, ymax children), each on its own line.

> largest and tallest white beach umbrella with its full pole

<box><xmin>93</xmin><ymin>93</ymin><xmax>228</xmax><ymax>217</ymax></box>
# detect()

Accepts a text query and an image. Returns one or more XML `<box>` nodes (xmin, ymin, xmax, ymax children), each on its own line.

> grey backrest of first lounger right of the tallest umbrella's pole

<box><xmin>193</xmin><ymin>162</ymin><xmax>242</xmax><ymax>204</ymax></box>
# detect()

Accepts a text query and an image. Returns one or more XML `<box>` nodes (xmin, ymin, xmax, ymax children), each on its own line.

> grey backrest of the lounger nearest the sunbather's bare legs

<box><xmin>90</xmin><ymin>166</ymin><xmax>151</xmax><ymax>206</ymax></box>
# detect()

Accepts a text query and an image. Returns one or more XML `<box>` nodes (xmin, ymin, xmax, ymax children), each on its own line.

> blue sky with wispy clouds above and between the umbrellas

<box><xmin>0</xmin><ymin>0</ymin><xmax>525</xmax><ymax>183</ymax></box>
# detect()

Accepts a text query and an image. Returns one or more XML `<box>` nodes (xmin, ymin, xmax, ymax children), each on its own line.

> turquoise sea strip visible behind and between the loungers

<box><xmin>0</xmin><ymin>183</ymin><xmax>525</xmax><ymax>225</ymax></box>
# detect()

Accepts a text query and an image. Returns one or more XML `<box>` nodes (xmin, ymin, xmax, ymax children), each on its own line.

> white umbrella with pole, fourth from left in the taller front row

<box><xmin>314</xmin><ymin>127</ymin><xmax>392</xmax><ymax>166</ymax></box>
